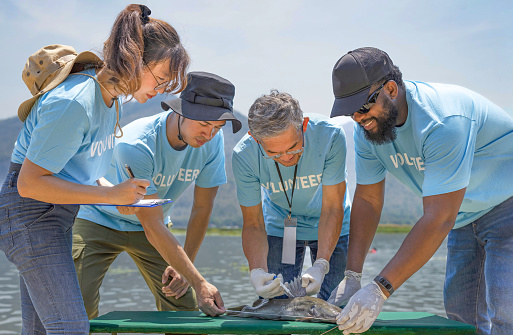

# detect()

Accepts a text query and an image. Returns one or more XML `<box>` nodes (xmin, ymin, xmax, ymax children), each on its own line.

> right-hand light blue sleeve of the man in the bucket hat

<box><xmin>195</xmin><ymin>131</ymin><xmax>226</xmax><ymax>188</ymax></box>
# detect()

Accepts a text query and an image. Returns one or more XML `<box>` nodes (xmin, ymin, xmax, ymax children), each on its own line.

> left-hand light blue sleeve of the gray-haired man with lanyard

<box><xmin>232</xmin><ymin>147</ymin><xmax>262</xmax><ymax>207</ymax></box>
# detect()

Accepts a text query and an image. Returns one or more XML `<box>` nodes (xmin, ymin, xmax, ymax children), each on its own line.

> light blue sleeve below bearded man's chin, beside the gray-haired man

<box><xmin>353</xmin><ymin>124</ymin><xmax>387</xmax><ymax>185</ymax></box>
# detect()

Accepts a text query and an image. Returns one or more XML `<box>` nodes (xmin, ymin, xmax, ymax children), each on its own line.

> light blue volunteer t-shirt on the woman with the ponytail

<box><xmin>11</xmin><ymin>69</ymin><xmax>121</xmax><ymax>185</ymax></box>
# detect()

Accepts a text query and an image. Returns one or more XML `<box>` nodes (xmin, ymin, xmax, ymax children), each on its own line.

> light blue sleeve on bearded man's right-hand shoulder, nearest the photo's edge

<box><xmin>422</xmin><ymin>116</ymin><xmax>477</xmax><ymax>196</ymax></box>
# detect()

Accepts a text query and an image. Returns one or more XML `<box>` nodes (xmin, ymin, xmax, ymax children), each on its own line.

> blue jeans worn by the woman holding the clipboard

<box><xmin>0</xmin><ymin>163</ymin><xmax>89</xmax><ymax>335</ymax></box>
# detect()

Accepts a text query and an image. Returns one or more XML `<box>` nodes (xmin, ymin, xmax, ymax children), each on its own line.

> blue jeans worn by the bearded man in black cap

<box><xmin>444</xmin><ymin>197</ymin><xmax>513</xmax><ymax>335</ymax></box>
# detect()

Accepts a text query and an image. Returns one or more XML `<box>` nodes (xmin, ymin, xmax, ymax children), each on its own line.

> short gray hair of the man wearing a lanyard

<box><xmin>248</xmin><ymin>90</ymin><xmax>303</xmax><ymax>141</ymax></box>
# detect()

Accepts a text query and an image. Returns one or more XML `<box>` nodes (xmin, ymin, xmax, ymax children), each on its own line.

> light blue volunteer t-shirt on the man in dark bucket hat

<box><xmin>78</xmin><ymin>112</ymin><xmax>226</xmax><ymax>231</ymax></box>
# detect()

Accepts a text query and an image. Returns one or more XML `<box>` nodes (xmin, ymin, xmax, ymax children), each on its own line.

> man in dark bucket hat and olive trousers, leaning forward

<box><xmin>73</xmin><ymin>72</ymin><xmax>241</xmax><ymax>319</ymax></box>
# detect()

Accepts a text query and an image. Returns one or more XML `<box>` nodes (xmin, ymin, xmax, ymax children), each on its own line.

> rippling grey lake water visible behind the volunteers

<box><xmin>0</xmin><ymin>234</ymin><xmax>447</xmax><ymax>334</ymax></box>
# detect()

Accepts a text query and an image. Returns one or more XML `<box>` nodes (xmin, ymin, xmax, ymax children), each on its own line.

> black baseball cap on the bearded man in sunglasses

<box><xmin>331</xmin><ymin>47</ymin><xmax>394</xmax><ymax>117</ymax></box>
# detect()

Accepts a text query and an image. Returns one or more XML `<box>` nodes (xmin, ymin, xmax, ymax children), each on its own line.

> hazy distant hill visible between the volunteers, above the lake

<box><xmin>0</xmin><ymin>95</ymin><xmax>422</xmax><ymax>227</ymax></box>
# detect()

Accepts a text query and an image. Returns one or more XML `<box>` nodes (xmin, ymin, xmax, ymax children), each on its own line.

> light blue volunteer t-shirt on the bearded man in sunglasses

<box><xmin>354</xmin><ymin>81</ymin><xmax>513</xmax><ymax>228</ymax></box>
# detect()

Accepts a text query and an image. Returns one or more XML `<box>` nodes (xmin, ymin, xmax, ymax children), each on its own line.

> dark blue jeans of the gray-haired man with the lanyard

<box><xmin>267</xmin><ymin>235</ymin><xmax>349</xmax><ymax>300</ymax></box>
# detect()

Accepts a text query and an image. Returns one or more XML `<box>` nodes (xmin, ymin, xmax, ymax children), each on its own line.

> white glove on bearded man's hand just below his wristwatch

<box><xmin>337</xmin><ymin>280</ymin><xmax>387</xmax><ymax>335</ymax></box>
